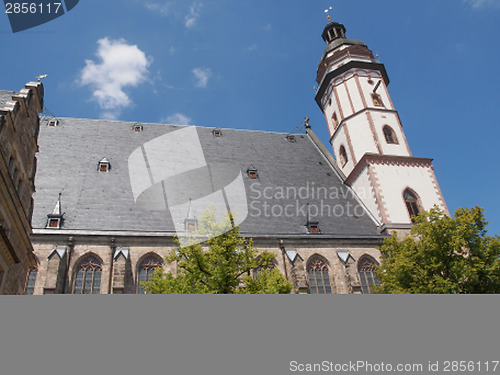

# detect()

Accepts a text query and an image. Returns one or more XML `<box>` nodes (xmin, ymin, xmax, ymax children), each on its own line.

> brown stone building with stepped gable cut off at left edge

<box><xmin>0</xmin><ymin>82</ymin><xmax>43</xmax><ymax>294</ymax></box>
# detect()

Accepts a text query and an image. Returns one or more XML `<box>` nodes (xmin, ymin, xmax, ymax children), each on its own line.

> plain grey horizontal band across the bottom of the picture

<box><xmin>0</xmin><ymin>296</ymin><xmax>500</xmax><ymax>375</ymax></box>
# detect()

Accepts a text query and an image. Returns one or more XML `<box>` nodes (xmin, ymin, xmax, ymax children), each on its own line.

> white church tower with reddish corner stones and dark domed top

<box><xmin>316</xmin><ymin>22</ymin><xmax>448</xmax><ymax>231</ymax></box>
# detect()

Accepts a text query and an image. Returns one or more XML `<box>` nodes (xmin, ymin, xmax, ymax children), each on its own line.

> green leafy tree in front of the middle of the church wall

<box><xmin>143</xmin><ymin>210</ymin><xmax>292</xmax><ymax>294</ymax></box>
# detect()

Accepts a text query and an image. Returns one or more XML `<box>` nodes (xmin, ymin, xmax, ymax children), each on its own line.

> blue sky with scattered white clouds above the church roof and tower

<box><xmin>0</xmin><ymin>0</ymin><xmax>500</xmax><ymax>234</ymax></box>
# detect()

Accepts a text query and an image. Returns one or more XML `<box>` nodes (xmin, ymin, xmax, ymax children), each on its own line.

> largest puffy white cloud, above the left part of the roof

<box><xmin>79</xmin><ymin>37</ymin><xmax>150</xmax><ymax>119</ymax></box>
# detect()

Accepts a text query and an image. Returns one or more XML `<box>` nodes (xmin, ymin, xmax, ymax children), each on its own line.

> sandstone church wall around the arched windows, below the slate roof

<box><xmin>29</xmin><ymin>235</ymin><xmax>380</xmax><ymax>294</ymax></box>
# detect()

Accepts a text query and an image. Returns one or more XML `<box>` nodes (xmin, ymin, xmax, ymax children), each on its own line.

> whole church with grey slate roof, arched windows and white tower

<box><xmin>18</xmin><ymin>22</ymin><xmax>447</xmax><ymax>294</ymax></box>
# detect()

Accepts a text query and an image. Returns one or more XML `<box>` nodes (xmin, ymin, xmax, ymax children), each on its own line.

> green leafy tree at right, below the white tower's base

<box><xmin>375</xmin><ymin>206</ymin><xmax>500</xmax><ymax>294</ymax></box>
